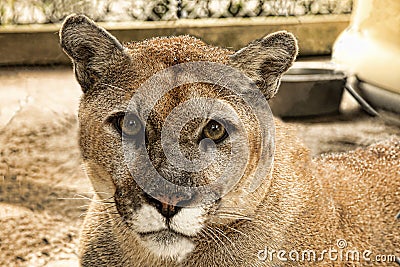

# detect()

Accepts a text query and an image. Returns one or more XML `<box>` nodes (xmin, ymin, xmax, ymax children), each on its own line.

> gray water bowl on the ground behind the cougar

<box><xmin>269</xmin><ymin>62</ymin><xmax>346</xmax><ymax>117</ymax></box>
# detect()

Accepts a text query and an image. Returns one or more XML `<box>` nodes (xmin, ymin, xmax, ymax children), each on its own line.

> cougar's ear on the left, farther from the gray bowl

<box><xmin>60</xmin><ymin>14</ymin><xmax>130</xmax><ymax>93</ymax></box>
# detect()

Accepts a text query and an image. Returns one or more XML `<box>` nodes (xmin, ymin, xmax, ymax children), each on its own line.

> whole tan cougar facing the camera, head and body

<box><xmin>60</xmin><ymin>15</ymin><xmax>400</xmax><ymax>267</ymax></box>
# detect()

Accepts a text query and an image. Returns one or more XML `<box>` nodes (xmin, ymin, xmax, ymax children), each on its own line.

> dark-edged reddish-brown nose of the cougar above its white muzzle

<box><xmin>146</xmin><ymin>193</ymin><xmax>191</xmax><ymax>219</ymax></box>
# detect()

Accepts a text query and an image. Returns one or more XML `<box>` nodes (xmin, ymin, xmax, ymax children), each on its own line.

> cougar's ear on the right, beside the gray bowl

<box><xmin>230</xmin><ymin>31</ymin><xmax>298</xmax><ymax>99</ymax></box>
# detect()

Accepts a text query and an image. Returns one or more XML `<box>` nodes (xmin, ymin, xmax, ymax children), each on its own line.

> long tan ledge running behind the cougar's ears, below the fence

<box><xmin>0</xmin><ymin>15</ymin><xmax>350</xmax><ymax>66</ymax></box>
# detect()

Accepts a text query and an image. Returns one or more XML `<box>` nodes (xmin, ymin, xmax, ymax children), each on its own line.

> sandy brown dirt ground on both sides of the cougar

<box><xmin>0</xmin><ymin>67</ymin><xmax>400</xmax><ymax>266</ymax></box>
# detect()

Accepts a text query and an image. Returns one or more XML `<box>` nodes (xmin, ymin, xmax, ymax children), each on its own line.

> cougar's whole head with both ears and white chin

<box><xmin>60</xmin><ymin>15</ymin><xmax>297</xmax><ymax>260</ymax></box>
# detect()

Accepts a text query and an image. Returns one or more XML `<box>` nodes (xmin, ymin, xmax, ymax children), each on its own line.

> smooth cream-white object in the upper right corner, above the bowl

<box><xmin>332</xmin><ymin>0</ymin><xmax>400</xmax><ymax>94</ymax></box>
